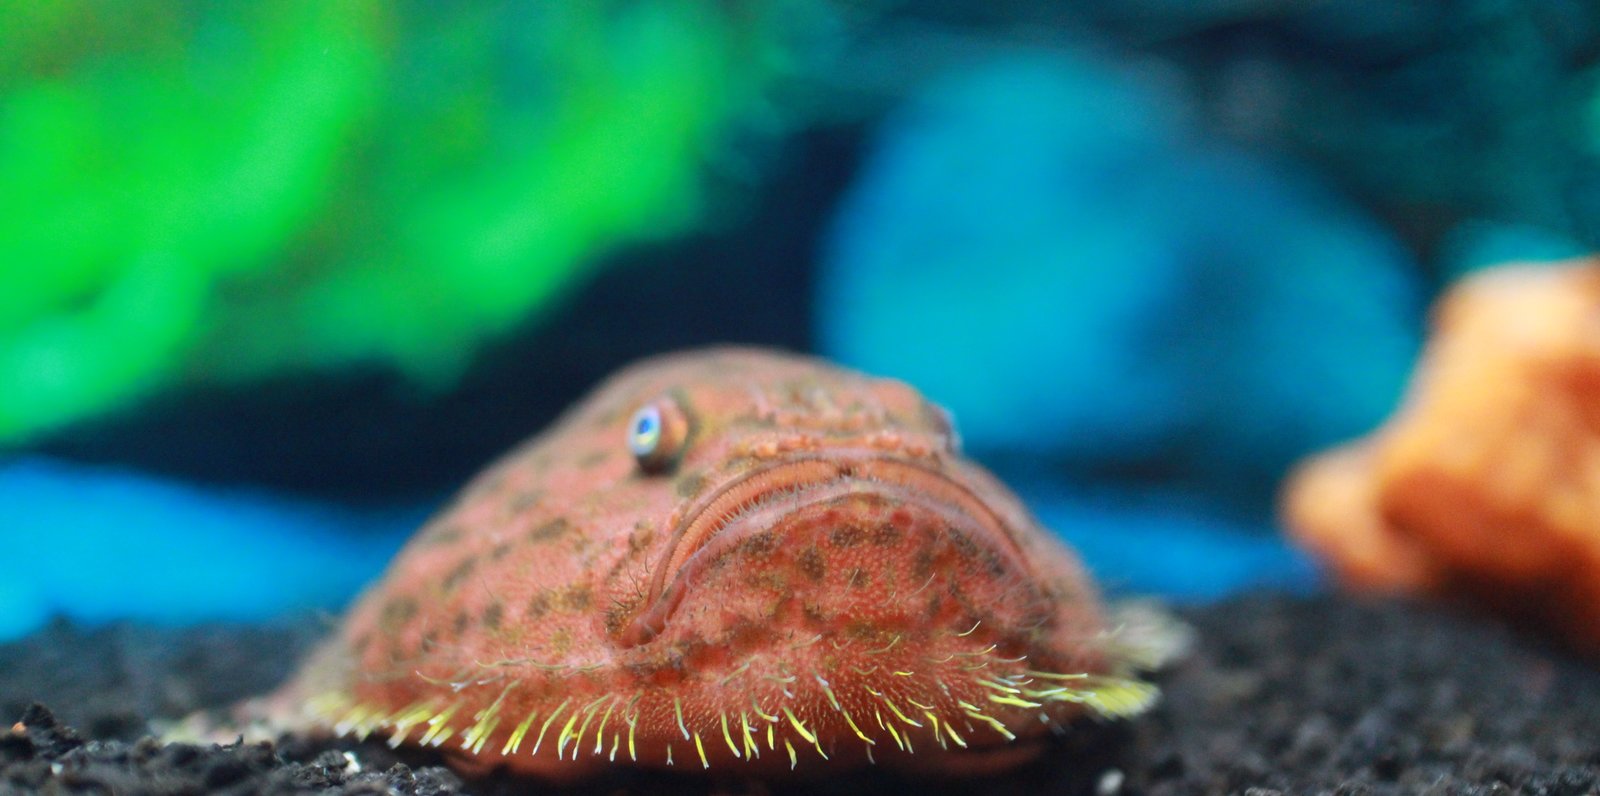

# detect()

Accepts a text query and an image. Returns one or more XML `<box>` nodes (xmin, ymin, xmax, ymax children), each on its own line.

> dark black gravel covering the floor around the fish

<box><xmin>0</xmin><ymin>596</ymin><xmax>1600</xmax><ymax>796</ymax></box>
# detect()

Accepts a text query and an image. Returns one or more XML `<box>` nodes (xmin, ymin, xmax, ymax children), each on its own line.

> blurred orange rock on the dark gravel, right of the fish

<box><xmin>1285</xmin><ymin>261</ymin><xmax>1600</xmax><ymax>655</ymax></box>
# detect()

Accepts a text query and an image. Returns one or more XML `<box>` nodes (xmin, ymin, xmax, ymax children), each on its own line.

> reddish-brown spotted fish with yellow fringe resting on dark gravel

<box><xmin>269</xmin><ymin>348</ymin><xmax>1154</xmax><ymax>778</ymax></box>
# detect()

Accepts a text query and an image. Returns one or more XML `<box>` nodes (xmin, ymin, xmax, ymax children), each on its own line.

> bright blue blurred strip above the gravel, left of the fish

<box><xmin>0</xmin><ymin>459</ymin><xmax>426</xmax><ymax>639</ymax></box>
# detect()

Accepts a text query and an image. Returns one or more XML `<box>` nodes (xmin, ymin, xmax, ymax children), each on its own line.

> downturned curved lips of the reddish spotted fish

<box><xmin>619</xmin><ymin>452</ymin><xmax>1032</xmax><ymax>646</ymax></box>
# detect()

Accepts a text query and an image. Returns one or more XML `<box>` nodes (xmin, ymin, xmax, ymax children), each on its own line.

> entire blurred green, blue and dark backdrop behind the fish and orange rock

<box><xmin>0</xmin><ymin>0</ymin><xmax>1600</xmax><ymax>636</ymax></box>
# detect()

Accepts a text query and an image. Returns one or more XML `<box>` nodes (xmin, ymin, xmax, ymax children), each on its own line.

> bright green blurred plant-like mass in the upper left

<box><xmin>0</xmin><ymin>0</ymin><xmax>816</xmax><ymax>443</ymax></box>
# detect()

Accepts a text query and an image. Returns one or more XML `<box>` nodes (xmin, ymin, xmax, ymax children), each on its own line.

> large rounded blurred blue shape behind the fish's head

<box><xmin>818</xmin><ymin>54</ymin><xmax>1424</xmax><ymax>497</ymax></box>
